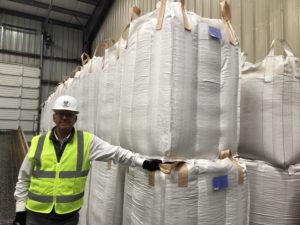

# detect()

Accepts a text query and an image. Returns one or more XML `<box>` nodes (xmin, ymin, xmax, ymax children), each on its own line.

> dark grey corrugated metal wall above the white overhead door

<box><xmin>0</xmin><ymin>14</ymin><xmax>83</xmax><ymax>101</ymax></box>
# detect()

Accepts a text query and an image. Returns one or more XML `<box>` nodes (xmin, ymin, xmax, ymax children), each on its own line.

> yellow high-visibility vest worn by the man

<box><xmin>26</xmin><ymin>131</ymin><xmax>92</xmax><ymax>214</ymax></box>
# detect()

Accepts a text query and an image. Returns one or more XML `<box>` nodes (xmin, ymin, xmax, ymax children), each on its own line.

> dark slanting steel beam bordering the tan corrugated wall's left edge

<box><xmin>83</xmin><ymin>0</ymin><xmax>115</xmax><ymax>54</ymax></box>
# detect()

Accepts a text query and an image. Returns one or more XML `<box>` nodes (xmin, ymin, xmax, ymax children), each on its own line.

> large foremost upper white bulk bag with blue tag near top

<box><xmin>120</xmin><ymin>1</ymin><xmax>239</xmax><ymax>159</ymax></box>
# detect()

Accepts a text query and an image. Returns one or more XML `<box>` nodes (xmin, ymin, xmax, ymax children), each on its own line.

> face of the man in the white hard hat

<box><xmin>53</xmin><ymin>110</ymin><xmax>77</xmax><ymax>130</ymax></box>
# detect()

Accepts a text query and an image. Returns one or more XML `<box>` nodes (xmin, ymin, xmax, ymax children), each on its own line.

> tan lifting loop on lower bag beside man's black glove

<box><xmin>149</xmin><ymin>161</ymin><xmax>189</xmax><ymax>187</ymax></box>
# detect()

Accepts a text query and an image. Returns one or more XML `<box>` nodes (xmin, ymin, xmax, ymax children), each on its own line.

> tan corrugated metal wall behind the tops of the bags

<box><xmin>93</xmin><ymin>0</ymin><xmax>300</xmax><ymax>62</ymax></box>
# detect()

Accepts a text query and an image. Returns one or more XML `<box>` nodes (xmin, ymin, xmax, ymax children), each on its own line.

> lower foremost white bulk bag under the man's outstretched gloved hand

<box><xmin>123</xmin><ymin>158</ymin><xmax>249</xmax><ymax>225</ymax></box>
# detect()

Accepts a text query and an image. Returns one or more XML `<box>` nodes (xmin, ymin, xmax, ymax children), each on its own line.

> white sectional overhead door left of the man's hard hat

<box><xmin>0</xmin><ymin>63</ymin><xmax>40</xmax><ymax>138</ymax></box>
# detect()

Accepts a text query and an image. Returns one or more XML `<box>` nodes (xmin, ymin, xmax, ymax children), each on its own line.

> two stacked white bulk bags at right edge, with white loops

<box><xmin>238</xmin><ymin>40</ymin><xmax>300</xmax><ymax>225</ymax></box>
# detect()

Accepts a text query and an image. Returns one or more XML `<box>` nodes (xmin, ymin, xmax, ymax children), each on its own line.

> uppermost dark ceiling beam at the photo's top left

<box><xmin>9</xmin><ymin>0</ymin><xmax>90</xmax><ymax>19</ymax></box>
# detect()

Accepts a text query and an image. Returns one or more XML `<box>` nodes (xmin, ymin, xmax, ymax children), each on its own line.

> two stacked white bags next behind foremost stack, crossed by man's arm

<box><xmin>80</xmin><ymin>38</ymin><xmax>127</xmax><ymax>225</ymax></box>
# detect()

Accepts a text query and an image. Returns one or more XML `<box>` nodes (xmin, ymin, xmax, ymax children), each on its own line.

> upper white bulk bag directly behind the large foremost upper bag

<box><xmin>97</xmin><ymin>38</ymin><xmax>127</xmax><ymax>145</ymax></box>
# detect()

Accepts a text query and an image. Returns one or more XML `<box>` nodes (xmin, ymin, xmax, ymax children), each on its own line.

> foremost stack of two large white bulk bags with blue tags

<box><xmin>120</xmin><ymin>1</ymin><xmax>248</xmax><ymax>225</ymax></box>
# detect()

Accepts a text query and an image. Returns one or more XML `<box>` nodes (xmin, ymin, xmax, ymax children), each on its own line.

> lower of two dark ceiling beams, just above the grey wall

<box><xmin>0</xmin><ymin>7</ymin><xmax>83</xmax><ymax>30</ymax></box>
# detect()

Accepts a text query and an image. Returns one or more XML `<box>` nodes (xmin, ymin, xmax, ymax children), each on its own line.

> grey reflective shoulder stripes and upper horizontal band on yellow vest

<box><xmin>32</xmin><ymin>131</ymin><xmax>89</xmax><ymax>178</ymax></box>
